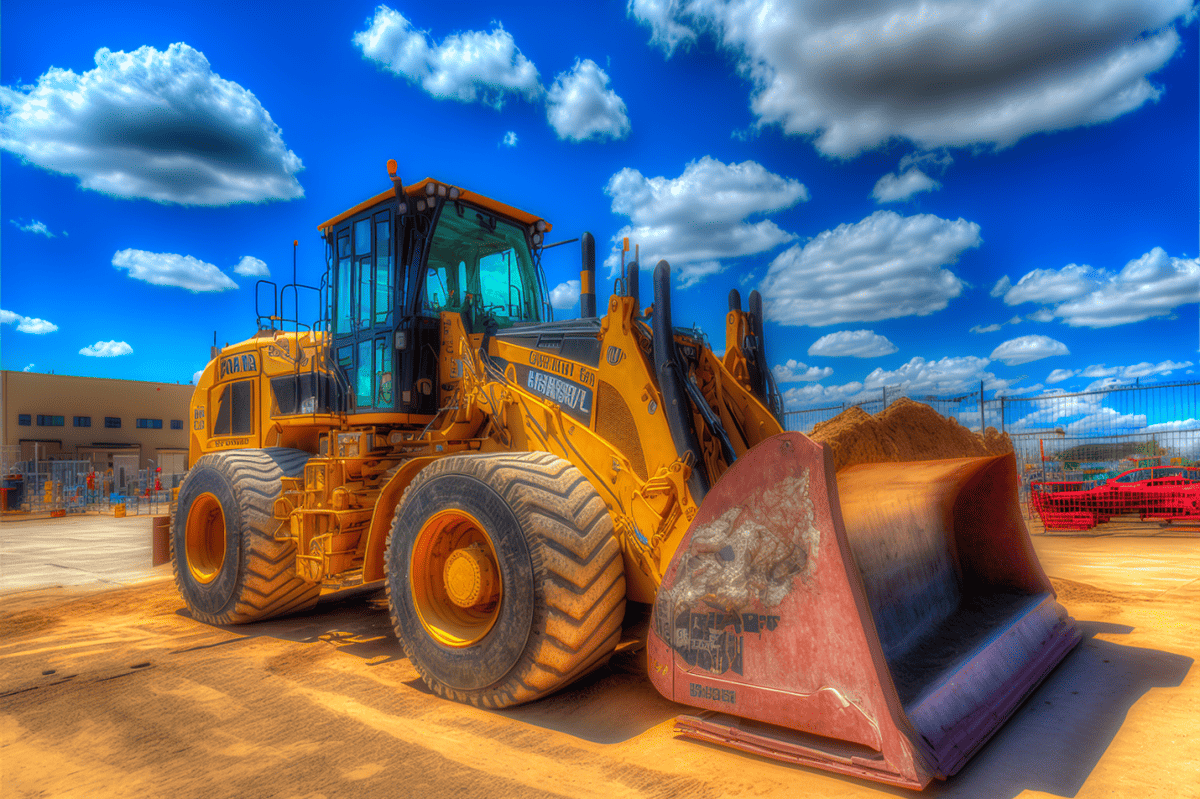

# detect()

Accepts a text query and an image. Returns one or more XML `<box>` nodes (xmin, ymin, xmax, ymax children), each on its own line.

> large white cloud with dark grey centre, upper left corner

<box><xmin>0</xmin><ymin>42</ymin><xmax>304</xmax><ymax>205</ymax></box>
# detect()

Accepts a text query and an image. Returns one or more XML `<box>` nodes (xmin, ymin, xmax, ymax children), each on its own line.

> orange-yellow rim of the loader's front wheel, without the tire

<box><xmin>409</xmin><ymin>510</ymin><xmax>503</xmax><ymax>648</ymax></box>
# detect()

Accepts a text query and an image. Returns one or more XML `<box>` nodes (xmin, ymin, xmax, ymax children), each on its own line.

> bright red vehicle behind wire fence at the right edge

<box><xmin>1030</xmin><ymin>467</ymin><xmax>1200</xmax><ymax>530</ymax></box>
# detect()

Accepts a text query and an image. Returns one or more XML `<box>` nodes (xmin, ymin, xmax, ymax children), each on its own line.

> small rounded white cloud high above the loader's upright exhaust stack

<box><xmin>546</xmin><ymin>59</ymin><xmax>629</xmax><ymax>142</ymax></box>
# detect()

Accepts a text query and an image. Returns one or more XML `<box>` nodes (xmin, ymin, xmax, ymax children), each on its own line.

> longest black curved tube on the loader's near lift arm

<box><xmin>653</xmin><ymin>260</ymin><xmax>708</xmax><ymax>505</ymax></box>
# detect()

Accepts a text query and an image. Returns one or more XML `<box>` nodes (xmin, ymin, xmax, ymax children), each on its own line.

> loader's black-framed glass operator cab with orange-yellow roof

<box><xmin>320</xmin><ymin>178</ymin><xmax>552</xmax><ymax>423</ymax></box>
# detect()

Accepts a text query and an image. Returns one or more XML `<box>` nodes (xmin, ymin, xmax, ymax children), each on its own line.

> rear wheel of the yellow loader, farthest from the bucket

<box><xmin>170</xmin><ymin>447</ymin><xmax>320</xmax><ymax>624</ymax></box>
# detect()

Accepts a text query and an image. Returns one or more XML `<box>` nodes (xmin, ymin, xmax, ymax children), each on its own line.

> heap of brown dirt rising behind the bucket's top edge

<box><xmin>809</xmin><ymin>398</ymin><xmax>1013</xmax><ymax>471</ymax></box>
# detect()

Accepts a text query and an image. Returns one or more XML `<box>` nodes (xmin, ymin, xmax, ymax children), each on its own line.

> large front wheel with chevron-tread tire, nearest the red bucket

<box><xmin>386</xmin><ymin>452</ymin><xmax>625</xmax><ymax>708</ymax></box>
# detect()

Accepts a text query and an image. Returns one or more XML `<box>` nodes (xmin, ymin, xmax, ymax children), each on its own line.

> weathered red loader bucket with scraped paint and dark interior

<box><xmin>648</xmin><ymin>433</ymin><xmax>1080</xmax><ymax>789</ymax></box>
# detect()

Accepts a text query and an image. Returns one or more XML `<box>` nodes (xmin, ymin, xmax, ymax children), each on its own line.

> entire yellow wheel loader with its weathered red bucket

<box><xmin>170</xmin><ymin>162</ymin><xmax>1079</xmax><ymax>788</ymax></box>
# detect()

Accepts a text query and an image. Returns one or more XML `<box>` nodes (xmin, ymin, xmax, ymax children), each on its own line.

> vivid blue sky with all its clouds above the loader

<box><xmin>0</xmin><ymin>0</ymin><xmax>1200</xmax><ymax>407</ymax></box>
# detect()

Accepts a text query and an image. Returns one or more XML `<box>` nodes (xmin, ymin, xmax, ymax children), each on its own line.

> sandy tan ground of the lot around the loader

<box><xmin>0</xmin><ymin>516</ymin><xmax>1200</xmax><ymax>799</ymax></box>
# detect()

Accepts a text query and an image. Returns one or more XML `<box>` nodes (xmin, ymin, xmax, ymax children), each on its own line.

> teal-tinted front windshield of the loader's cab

<box><xmin>420</xmin><ymin>203</ymin><xmax>542</xmax><ymax>328</ymax></box>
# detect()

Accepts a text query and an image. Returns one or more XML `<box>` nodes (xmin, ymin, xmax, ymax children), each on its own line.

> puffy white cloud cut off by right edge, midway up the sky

<box><xmin>1004</xmin><ymin>247</ymin><xmax>1200</xmax><ymax>328</ymax></box>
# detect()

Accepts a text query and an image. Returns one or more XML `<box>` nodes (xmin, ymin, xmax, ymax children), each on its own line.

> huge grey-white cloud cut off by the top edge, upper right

<box><xmin>628</xmin><ymin>0</ymin><xmax>1193</xmax><ymax>157</ymax></box>
